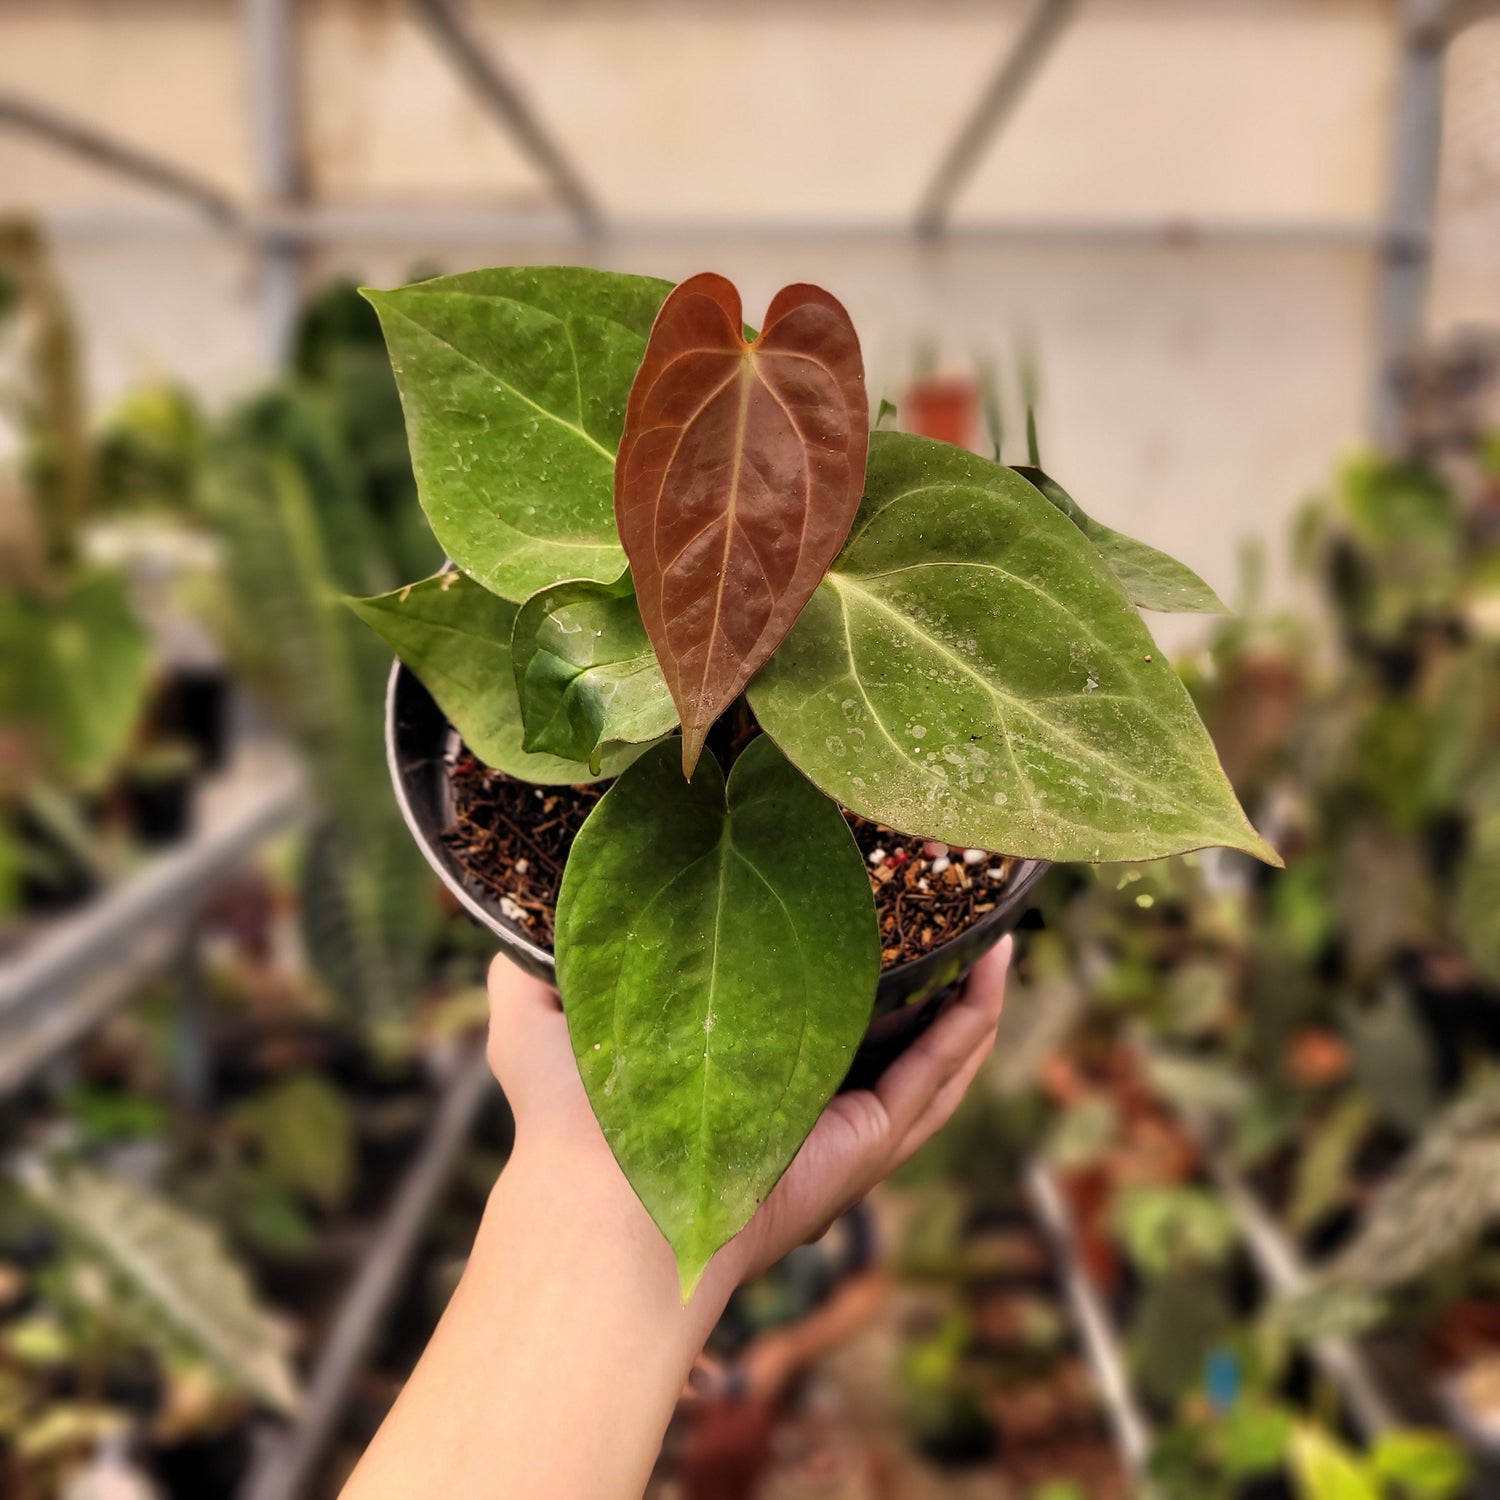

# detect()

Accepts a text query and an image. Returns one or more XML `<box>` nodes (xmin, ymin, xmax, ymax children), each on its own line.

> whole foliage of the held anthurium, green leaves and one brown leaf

<box><xmin>351</xmin><ymin>267</ymin><xmax>1277</xmax><ymax>1295</ymax></box>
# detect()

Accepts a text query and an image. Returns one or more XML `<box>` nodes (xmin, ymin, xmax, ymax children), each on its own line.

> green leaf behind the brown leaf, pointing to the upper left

<box><xmin>365</xmin><ymin>266</ymin><xmax>672</xmax><ymax>605</ymax></box>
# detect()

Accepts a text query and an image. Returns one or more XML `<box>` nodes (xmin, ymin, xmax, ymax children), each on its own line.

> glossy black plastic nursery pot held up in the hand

<box><xmin>386</xmin><ymin>662</ymin><xmax>1049</xmax><ymax>1088</ymax></box>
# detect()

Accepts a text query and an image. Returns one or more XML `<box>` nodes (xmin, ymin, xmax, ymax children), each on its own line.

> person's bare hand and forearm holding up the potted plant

<box><xmin>344</xmin><ymin>941</ymin><xmax>1010</xmax><ymax>1500</ymax></box>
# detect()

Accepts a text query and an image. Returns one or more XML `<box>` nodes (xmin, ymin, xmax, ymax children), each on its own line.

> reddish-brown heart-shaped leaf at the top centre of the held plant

<box><xmin>615</xmin><ymin>273</ymin><xmax>870</xmax><ymax>776</ymax></box>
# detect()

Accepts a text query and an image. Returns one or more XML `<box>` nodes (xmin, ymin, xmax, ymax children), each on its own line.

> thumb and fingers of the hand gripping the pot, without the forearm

<box><xmin>489</xmin><ymin>938</ymin><xmax>1013</xmax><ymax>1296</ymax></box>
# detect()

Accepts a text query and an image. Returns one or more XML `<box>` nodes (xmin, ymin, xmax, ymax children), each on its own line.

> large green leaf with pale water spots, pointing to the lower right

<box><xmin>750</xmin><ymin>432</ymin><xmax>1281</xmax><ymax>864</ymax></box>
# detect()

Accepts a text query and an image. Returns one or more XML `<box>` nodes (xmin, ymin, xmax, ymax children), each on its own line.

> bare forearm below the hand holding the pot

<box><xmin>344</xmin><ymin>1154</ymin><xmax>734</xmax><ymax>1500</ymax></box>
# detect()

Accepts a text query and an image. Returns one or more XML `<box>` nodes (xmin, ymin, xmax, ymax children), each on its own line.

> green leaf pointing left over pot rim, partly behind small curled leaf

<box><xmin>345</xmin><ymin>572</ymin><xmax>635</xmax><ymax>786</ymax></box>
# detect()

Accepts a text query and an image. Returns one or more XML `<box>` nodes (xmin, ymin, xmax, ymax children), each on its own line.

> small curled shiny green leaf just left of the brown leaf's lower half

<box><xmin>510</xmin><ymin>575</ymin><xmax>677</xmax><ymax>771</ymax></box>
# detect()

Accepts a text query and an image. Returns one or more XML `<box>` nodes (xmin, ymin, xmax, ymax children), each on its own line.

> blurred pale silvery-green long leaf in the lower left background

<box><xmin>17</xmin><ymin>1158</ymin><xmax>299</xmax><ymax>1413</ymax></box>
